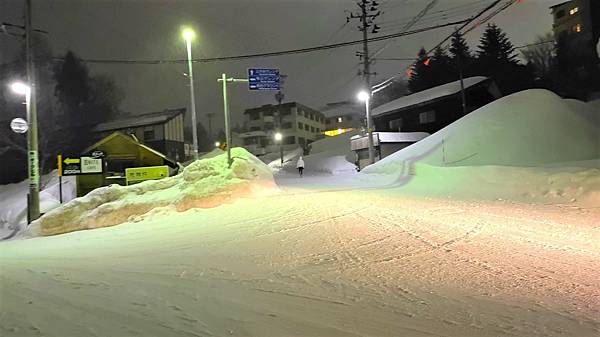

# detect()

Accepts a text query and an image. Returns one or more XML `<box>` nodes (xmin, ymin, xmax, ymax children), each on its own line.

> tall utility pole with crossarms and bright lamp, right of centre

<box><xmin>346</xmin><ymin>0</ymin><xmax>381</xmax><ymax>164</ymax></box>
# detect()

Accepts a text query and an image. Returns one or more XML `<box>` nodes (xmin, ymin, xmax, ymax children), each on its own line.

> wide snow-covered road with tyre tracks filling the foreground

<box><xmin>0</xmin><ymin>177</ymin><xmax>600</xmax><ymax>337</ymax></box>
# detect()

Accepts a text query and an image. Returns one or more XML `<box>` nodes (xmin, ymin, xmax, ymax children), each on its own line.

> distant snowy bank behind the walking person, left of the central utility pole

<box><xmin>276</xmin><ymin>131</ymin><xmax>358</xmax><ymax>175</ymax></box>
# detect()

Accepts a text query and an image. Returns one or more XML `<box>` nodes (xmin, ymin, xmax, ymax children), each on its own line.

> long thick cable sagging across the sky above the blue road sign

<box><xmin>53</xmin><ymin>20</ymin><xmax>466</xmax><ymax>65</ymax></box>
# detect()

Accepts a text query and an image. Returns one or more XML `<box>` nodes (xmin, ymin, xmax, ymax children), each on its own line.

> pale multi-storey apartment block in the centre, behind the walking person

<box><xmin>239</xmin><ymin>102</ymin><xmax>325</xmax><ymax>155</ymax></box>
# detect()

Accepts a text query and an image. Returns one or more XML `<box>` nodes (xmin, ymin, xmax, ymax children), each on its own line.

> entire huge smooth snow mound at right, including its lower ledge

<box><xmin>362</xmin><ymin>90</ymin><xmax>600</xmax><ymax>206</ymax></box>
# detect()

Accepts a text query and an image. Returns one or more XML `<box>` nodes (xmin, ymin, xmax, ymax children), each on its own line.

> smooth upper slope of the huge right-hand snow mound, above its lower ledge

<box><xmin>363</xmin><ymin>89</ymin><xmax>600</xmax><ymax>174</ymax></box>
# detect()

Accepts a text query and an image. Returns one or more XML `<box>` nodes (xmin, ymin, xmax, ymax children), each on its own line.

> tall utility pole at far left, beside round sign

<box><xmin>25</xmin><ymin>0</ymin><xmax>40</xmax><ymax>221</ymax></box>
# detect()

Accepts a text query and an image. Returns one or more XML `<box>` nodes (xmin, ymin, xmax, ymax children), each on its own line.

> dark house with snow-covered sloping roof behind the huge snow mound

<box><xmin>371</xmin><ymin>76</ymin><xmax>501</xmax><ymax>134</ymax></box>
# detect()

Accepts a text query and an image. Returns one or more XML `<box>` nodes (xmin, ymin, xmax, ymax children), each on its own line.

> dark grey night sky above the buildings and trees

<box><xmin>0</xmin><ymin>0</ymin><xmax>560</xmax><ymax>129</ymax></box>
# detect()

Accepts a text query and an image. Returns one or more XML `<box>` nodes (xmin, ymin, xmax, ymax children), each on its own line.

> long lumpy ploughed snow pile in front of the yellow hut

<box><xmin>27</xmin><ymin>148</ymin><xmax>276</xmax><ymax>236</ymax></box>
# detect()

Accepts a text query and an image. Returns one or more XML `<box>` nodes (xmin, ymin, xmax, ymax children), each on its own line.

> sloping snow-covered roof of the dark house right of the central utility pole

<box><xmin>371</xmin><ymin>76</ymin><xmax>488</xmax><ymax>116</ymax></box>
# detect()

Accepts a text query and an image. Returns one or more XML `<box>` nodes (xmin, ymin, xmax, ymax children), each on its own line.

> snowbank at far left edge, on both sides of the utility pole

<box><xmin>0</xmin><ymin>170</ymin><xmax>77</xmax><ymax>239</ymax></box>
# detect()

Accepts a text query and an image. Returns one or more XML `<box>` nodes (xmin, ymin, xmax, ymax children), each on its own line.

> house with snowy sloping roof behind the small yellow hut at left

<box><xmin>93</xmin><ymin>108</ymin><xmax>186</xmax><ymax>161</ymax></box>
